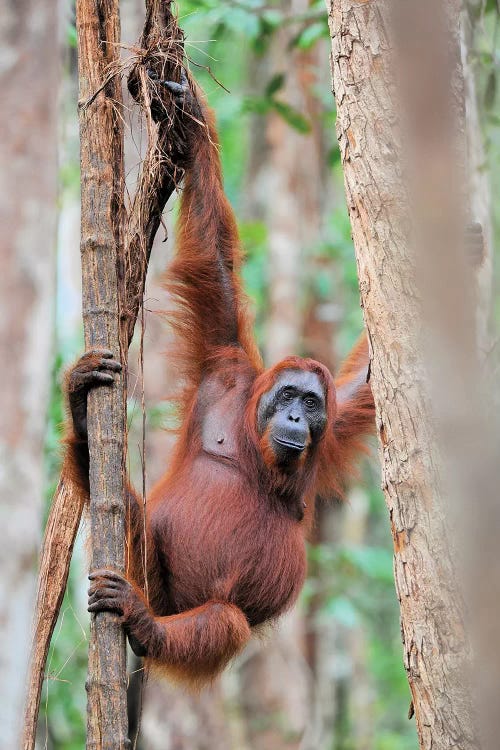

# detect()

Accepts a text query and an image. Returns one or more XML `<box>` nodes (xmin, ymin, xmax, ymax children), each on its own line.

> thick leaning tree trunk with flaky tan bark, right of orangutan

<box><xmin>329</xmin><ymin>0</ymin><xmax>478</xmax><ymax>750</ymax></box>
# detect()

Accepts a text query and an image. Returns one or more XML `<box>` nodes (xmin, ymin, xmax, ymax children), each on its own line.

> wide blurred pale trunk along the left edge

<box><xmin>0</xmin><ymin>0</ymin><xmax>59</xmax><ymax>750</ymax></box>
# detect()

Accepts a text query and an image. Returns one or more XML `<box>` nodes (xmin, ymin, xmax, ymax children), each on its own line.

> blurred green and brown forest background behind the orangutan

<box><xmin>4</xmin><ymin>0</ymin><xmax>500</xmax><ymax>750</ymax></box>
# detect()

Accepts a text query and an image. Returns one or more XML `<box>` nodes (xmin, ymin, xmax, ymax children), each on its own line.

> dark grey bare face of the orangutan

<box><xmin>257</xmin><ymin>370</ymin><xmax>327</xmax><ymax>463</ymax></box>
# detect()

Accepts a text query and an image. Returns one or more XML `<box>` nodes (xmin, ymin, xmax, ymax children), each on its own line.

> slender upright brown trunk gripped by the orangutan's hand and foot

<box><xmin>76</xmin><ymin>0</ymin><xmax>128</xmax><ymax>749</ymax></box>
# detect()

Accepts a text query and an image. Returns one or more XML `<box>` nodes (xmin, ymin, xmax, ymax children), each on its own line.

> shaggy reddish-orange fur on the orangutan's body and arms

<box><xmin>64</xmin><ymin>86</ymin><xmax>373</xmax><ymax>687</ymax></box>
